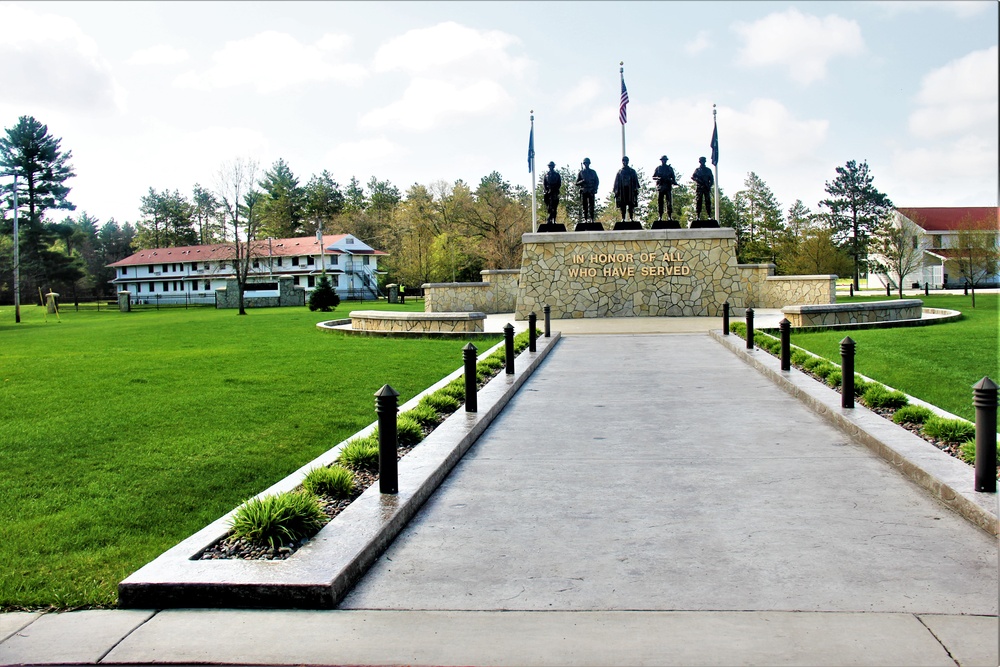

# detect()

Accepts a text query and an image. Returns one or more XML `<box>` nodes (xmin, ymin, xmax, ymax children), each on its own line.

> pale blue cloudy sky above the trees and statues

<box><xmin>0</xmin><ymin>0</ymin><xmax>998</xmax><ymax>227</ymax></box>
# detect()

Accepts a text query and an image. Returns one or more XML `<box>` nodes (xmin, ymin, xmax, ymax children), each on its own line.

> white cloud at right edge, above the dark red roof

<box><xmin>910</xmin><ymin>46</ymin><xmax>998</xmax><ymax>139</ymax></box>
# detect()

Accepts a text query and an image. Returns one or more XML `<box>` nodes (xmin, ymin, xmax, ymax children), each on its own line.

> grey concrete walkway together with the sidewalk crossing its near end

<box><xmin>0</xmin><ymin>330</ymin><xmax>998</xmax><ymax>666</ymax></box>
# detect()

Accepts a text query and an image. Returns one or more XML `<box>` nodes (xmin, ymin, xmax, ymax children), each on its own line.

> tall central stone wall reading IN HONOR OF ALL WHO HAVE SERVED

<box><xmin>515</xmin><ymin>229</ymin><xmax>752</xmax><ymax>319</ymax></box>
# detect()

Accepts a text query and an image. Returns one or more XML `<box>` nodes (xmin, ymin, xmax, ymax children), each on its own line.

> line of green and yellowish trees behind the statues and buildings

<box><xmin>0</xmin><ymin>116</ymin><xmax>996</xmax><ymax>310</ymax></box>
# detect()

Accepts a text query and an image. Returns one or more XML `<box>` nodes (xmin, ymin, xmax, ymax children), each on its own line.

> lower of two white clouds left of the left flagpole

<box><xmin>360</xmin><ymin>79</ymin><xmax>511</xmax><ymax>130</ymax></box>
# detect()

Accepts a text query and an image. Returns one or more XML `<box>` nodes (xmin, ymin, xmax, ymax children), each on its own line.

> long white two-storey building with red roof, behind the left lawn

<box><xmin>108</xmin><ymin>234</ymin><xmax>387</xmax><ymax>303</ymax></box>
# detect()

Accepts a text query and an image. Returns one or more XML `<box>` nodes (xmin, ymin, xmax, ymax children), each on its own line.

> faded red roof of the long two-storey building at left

<box><xmin>108</xmin><ymin>234</ymin><xmax>388</xmax><ymax>266</ymax></box>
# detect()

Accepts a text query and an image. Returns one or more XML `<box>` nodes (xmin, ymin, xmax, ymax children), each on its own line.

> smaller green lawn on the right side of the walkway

<box><xmin>792</xmin><ymin>293</ymin><xmax>1000</xmax><ymax>420</ymax></box>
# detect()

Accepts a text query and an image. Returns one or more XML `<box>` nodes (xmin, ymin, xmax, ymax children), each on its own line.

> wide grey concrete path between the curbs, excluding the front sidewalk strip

<box><xmin>340</xmin><ymin>335</ymin><xmax>997</xmax><ymax>614</ymax></box>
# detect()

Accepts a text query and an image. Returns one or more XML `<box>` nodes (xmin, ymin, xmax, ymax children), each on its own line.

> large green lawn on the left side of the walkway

<box><xmin>0</xmin><ymin>302</ymin><xmax>499</xmax><ymax>609</ymax></box>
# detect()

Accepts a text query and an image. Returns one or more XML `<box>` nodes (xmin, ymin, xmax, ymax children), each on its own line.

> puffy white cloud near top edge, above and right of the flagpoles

<box><xmin>733</xmin><ymin>7</ymin><xmax>864</xmax><ymax>84</ymax></box>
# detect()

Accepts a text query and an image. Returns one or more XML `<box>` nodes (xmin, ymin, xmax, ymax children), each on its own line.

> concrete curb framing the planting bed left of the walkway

<box><xmin>118</xmin><ymin>332</ymin><xmax>559</xmax><ymax>609</ymax></box>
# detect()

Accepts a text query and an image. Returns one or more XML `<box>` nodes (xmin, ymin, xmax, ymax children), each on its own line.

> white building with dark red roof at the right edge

<box><xmin>868</xmin><ymin>206</ymin><xmax>1000</xmax><ymax>289</ymax></box>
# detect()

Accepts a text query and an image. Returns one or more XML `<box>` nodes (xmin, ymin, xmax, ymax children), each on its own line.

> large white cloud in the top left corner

<box><xmin>0</xmin><ymin>4</ymin><xmax>125</xmax><ymax>113</ymax></box>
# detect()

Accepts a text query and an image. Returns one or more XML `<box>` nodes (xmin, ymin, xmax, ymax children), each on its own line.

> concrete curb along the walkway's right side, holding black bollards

<box><xmin>709</xmin><ymin>331</ymin><xmax>998</xmax><ymax>536</ymax></box>
